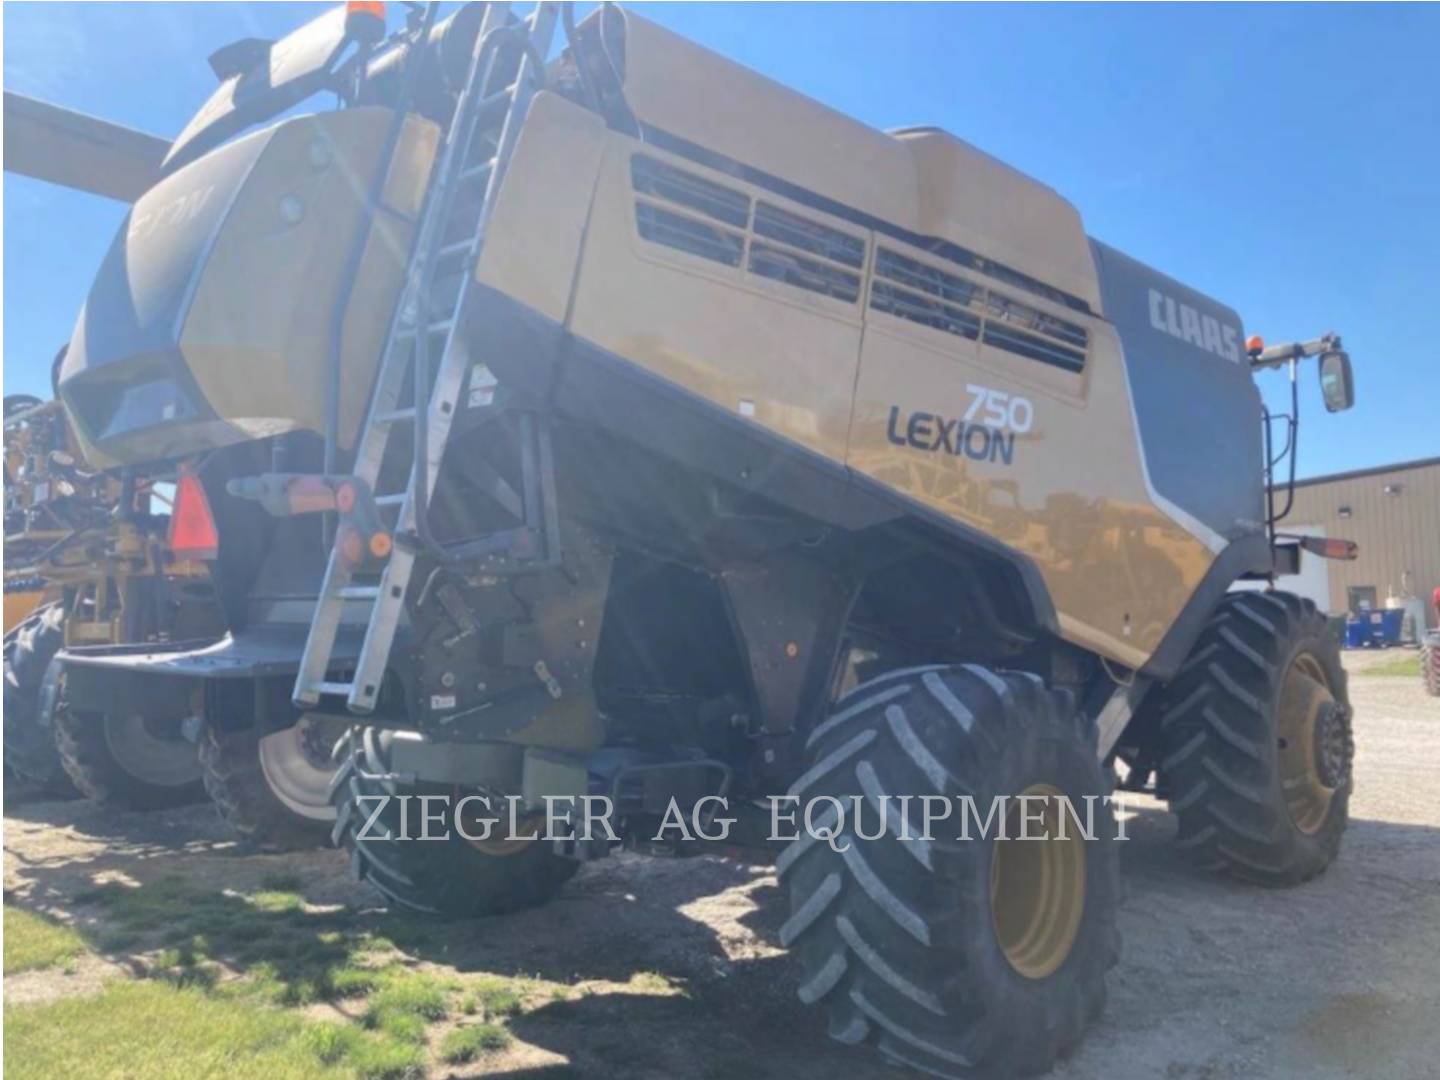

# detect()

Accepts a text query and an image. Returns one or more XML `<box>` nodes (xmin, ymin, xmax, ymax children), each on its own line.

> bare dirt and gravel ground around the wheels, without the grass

<box><xmin>4</xmin><ymin>654</ymin><xmax>1440</xmax><ymax>1080</ymax></box>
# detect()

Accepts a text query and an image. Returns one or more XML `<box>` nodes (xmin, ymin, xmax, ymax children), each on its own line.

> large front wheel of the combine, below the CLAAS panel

<box><xmin>1158</xmin><ymin>592</ymin><xmax>1355</xmax><ymax>886</ymax></box>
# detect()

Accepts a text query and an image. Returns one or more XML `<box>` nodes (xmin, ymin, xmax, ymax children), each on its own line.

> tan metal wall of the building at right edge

<box><xmin>1277</xmin><ymin>458</ymin><xmax>1440</xmax><ymax>626</ymax></box>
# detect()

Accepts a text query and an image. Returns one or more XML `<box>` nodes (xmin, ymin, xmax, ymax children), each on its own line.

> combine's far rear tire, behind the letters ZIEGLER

<box><xmin>334</xmin><ymin>727</ymin><xmax>579</xmax><ymax>919</ymax></box>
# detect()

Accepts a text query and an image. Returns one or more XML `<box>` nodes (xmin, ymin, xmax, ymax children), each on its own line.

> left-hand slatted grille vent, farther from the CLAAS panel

<box><xmin>631</xmin><ymin>154</ymin><xmax>865</xmax><ymax>304</ymax></box>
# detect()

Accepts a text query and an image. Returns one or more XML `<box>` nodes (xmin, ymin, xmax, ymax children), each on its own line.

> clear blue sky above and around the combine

<box><xmin>4</xmin><ymin>1</ymin><xmax>1440</xmax><ymax>475</ymax></box>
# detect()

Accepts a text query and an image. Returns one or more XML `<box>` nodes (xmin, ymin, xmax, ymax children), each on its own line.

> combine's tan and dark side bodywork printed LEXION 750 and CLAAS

<box><xmin>478</xmin><ymin>14</ymin><xmax>1269</xmax><ymax>667</ymax></box>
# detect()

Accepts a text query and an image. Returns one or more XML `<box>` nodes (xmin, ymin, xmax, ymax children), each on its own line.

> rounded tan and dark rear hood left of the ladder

<box><xmin>59</xmin><ymin>108</ymin><xmax>439</xmax><ymax>467</ymax></box>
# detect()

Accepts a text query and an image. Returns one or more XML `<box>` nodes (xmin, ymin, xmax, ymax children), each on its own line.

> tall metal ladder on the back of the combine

<box><xmin>291</xmin><ymin>3</ymin><xmax>559</xmax><ymax>713</ymax></box>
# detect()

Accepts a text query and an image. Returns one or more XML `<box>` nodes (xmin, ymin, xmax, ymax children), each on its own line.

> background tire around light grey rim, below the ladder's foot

<box><xmin>200</xmin><ymin>724</ymin><xmax>336</xmax><ymax>851</ymax></box>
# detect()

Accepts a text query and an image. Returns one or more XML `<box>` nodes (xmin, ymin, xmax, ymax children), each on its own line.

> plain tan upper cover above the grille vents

<box><xmin>621</xmin><ymin>10</ymin><xmax>1100</xmax><ymax>311</ymax></box>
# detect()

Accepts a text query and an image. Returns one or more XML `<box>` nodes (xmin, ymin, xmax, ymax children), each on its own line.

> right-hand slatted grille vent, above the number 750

<box><xmin>870</xmin><ymin>248</ymin><xmax>1090</xmax><ymax>372</ymax></box>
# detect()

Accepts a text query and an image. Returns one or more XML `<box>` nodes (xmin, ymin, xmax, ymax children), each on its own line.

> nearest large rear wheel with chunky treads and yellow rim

<box><xmin>776</xmin><ymin>665</ymin><xmax>1120</xmax><ymax>1077</ymax></box>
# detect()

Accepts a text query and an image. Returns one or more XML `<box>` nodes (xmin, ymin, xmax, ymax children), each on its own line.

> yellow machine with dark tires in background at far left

<box><xmin>4</xmin><ymin>395</ymin><xmax>213</xmax><ymax>808</ymax></box>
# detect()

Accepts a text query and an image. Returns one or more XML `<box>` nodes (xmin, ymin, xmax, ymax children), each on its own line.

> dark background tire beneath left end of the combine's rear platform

<box><xmin>55</xmin><ymin>693</ymin><xmax>204</xmax><ymax>811</ymax></box>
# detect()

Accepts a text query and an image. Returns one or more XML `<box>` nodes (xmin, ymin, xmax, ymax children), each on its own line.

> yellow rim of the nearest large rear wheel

<box><xmin>991</xmin><ymin>783</ymin><xmax>1086</xmax><ymax>979</ymax></box>
